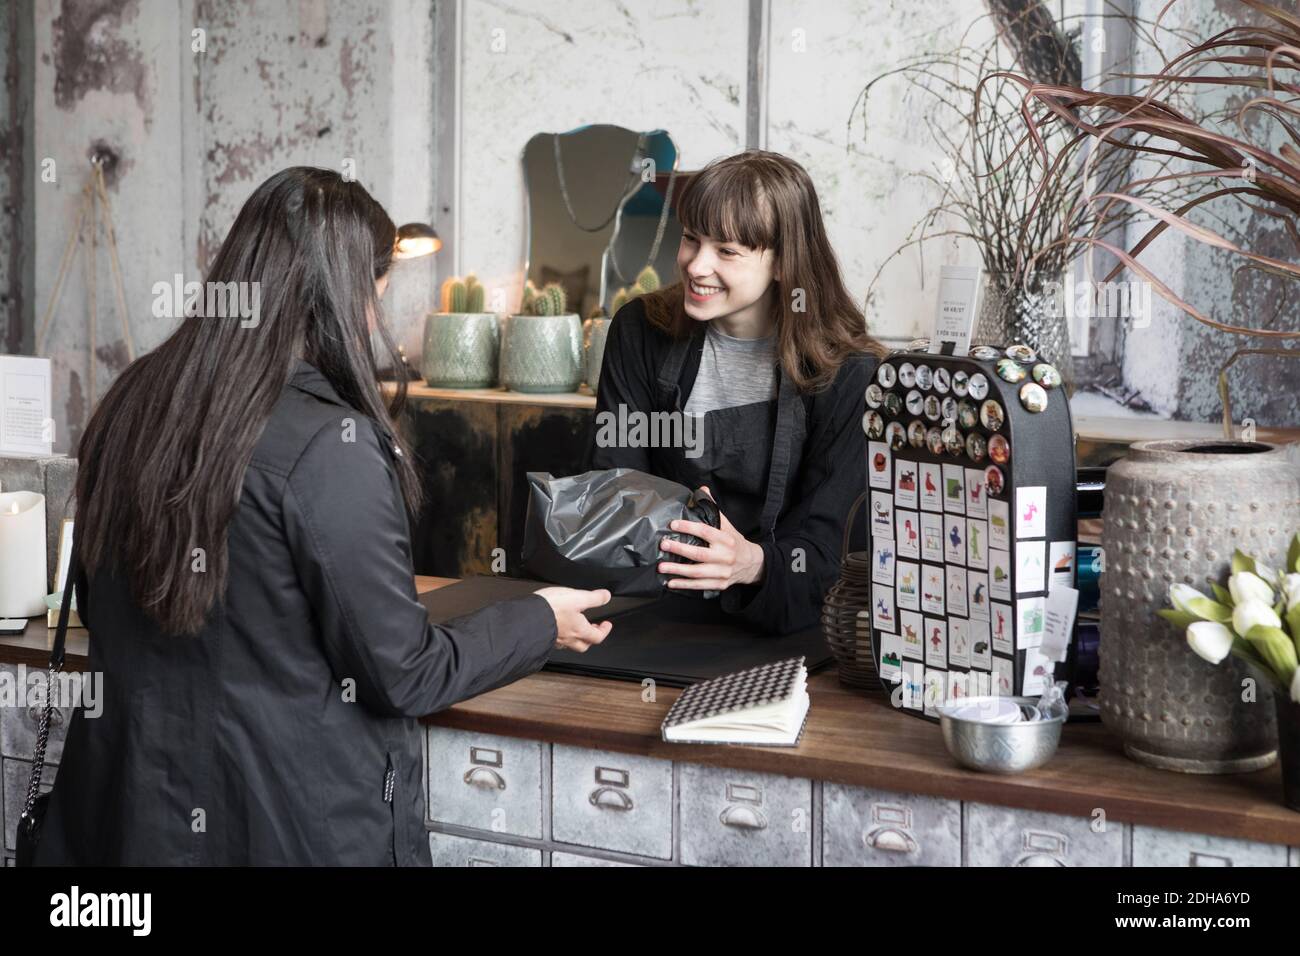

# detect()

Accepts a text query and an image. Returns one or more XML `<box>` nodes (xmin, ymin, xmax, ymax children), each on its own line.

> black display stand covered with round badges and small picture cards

<box><xmin>862</xmin><ymin>346</ymin><xmax>1076</xmax><ymax>719</ymax></box>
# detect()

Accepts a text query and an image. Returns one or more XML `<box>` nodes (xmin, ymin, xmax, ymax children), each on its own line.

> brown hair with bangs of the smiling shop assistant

<box><xmin>641</xmin><ymin>150</ymin><xmax>888</xmax><ymax>392</ymax></box>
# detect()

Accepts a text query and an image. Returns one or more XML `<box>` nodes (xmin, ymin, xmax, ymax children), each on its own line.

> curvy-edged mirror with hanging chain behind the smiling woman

<box><xmin>523</xmin><ymin>124</ymin><xmax>681</xmax><ymax>317</ymax></box>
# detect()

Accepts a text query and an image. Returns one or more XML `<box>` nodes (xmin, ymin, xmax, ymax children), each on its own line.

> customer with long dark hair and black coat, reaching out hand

<box><xmin>36</xmin><ymin>168</ymin><xmax>610</xmax><ymax>865</ymax></box>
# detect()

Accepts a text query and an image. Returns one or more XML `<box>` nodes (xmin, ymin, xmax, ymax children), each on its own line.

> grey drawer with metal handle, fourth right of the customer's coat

<box><xmin>822</xmin><ymin>783</ymin><xmax>962</xmax><ymax>866</ymax></box>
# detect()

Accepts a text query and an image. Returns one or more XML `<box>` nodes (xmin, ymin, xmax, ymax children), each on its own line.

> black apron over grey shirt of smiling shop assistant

<box><xmin>653</xmin><ymin>323</ymin><xmax>807</xmax><ymax>620</ymax></box>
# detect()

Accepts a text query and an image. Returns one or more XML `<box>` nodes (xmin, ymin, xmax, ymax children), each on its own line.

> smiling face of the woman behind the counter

<box><xmin>677</xmin><ymin>229</ymin><xmax>775</xmax><ymax>332</ymax></box>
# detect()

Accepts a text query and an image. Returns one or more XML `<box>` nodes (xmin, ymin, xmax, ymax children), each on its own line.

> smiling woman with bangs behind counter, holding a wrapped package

<box><xmin>588</xmin><ymin>150</ymin><xmax>885</xmax><ymax>632</ymax></box>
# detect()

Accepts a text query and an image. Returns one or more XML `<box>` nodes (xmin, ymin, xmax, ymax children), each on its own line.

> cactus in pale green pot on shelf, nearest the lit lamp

<box><xmin>420</xmin><ymin>273</ymin><xmax>501</xmax><ymax>389</ymax></box>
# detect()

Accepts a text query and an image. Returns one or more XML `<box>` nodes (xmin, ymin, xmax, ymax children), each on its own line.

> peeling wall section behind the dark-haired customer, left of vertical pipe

<box><xmin>27</xmin><ymin>0</ymin><xmax>434</xmax><ymax>451</ymax></box>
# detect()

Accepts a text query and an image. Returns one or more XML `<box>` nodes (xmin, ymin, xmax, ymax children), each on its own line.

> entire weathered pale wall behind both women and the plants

<box><xmin>10</xmin><ymin>0</ymin><xmax>1300</xmax><ymax>450</ymax></box>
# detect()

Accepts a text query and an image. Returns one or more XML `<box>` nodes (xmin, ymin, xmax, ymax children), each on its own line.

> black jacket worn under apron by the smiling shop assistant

<box><xmin>584</xmin><ymin>299</ymin><xmax>879</xmax><ymax>633</ymax></box>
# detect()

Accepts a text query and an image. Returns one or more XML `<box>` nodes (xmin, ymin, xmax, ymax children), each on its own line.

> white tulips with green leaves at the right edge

<box><xmin>1160</xmin><ymin>532</ymin><xmax>1300</xmax><ymax>704</ymax></box>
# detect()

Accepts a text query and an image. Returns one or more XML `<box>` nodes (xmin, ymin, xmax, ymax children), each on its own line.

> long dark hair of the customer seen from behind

<box><xmin>75</xmin><ymin>166</ymin><xmax>420</xmax><ymax>635</ymax></box>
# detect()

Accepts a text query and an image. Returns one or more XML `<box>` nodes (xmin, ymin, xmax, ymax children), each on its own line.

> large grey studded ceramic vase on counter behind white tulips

<box><xmin>1099</xmin><ymin>441</ymin><xmax>1300</xmax><ymax>774</ymax></box>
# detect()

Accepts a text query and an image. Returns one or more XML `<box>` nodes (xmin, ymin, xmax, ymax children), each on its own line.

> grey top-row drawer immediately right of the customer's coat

<box><xmin>429</xmin><ymin>727</ymin><xmax>542</xmax><ymax>839</ymax></box>
